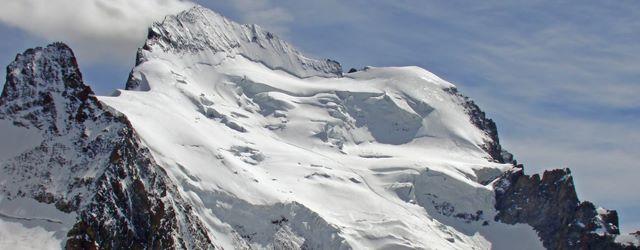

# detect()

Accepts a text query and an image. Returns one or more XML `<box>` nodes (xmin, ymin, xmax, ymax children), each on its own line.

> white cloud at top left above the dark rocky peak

<box><xmin>0</xmin><ymin>0</ymin><xmax>192</xmax><ymax>63</ymax></box>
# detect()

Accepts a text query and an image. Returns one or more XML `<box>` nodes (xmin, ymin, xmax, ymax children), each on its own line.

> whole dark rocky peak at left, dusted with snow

<box><xmin>0</xmin><ymin>43</ymin><xmax>213</xmax><ymax>249</ymax></box>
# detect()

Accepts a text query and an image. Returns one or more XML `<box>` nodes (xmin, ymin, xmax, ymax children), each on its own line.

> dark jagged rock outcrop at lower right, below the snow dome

<box><xmin>493</xmin><ymin>165</ymin><xmax>637</xmax><ymax>249</ymax></box>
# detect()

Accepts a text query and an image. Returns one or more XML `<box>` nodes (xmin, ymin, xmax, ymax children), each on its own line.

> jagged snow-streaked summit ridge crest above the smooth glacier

<box><xmin>139</xmin><ymin>6</ymin><xmax>342</xmax><ymax>77</ymax></box>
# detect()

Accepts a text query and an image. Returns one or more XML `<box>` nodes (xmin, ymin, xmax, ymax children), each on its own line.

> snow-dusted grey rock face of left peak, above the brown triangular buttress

<box><xmin>0</xmin><ymin>43</ymin><xmax>110</xmax><ymax>209</ymax></box>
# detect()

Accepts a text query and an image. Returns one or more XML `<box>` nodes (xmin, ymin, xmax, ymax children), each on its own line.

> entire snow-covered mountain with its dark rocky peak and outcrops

<box><xmin>0</xmin><ymin>6</ymin><xmax>638</xmax><ymax>249</ymax></box>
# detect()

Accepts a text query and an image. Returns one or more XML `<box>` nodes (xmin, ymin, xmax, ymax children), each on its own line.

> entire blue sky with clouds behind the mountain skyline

<box><xmin>0</xmin><ymin>0</ymin><xmax>640</xmax><ymax>231</ymax></box>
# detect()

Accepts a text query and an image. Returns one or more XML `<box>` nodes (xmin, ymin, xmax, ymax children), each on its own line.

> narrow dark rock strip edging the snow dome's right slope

<box><xmin>445</xmin><ymin>88</ymin><xmax>515</xmax><ymax>163</ymax></box>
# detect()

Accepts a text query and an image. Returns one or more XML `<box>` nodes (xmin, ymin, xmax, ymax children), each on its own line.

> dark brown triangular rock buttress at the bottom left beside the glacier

<box><xmin>67</xmin><ymin>125</ymin><xmax>214</xmax><ymax>249</ymax></box>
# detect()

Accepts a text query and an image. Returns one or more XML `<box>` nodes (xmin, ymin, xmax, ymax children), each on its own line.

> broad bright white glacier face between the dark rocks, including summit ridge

<box><xmin>99</xmin><ymin>8</ymin><xmax>542</xmax><ymax>249</ymax></box>
